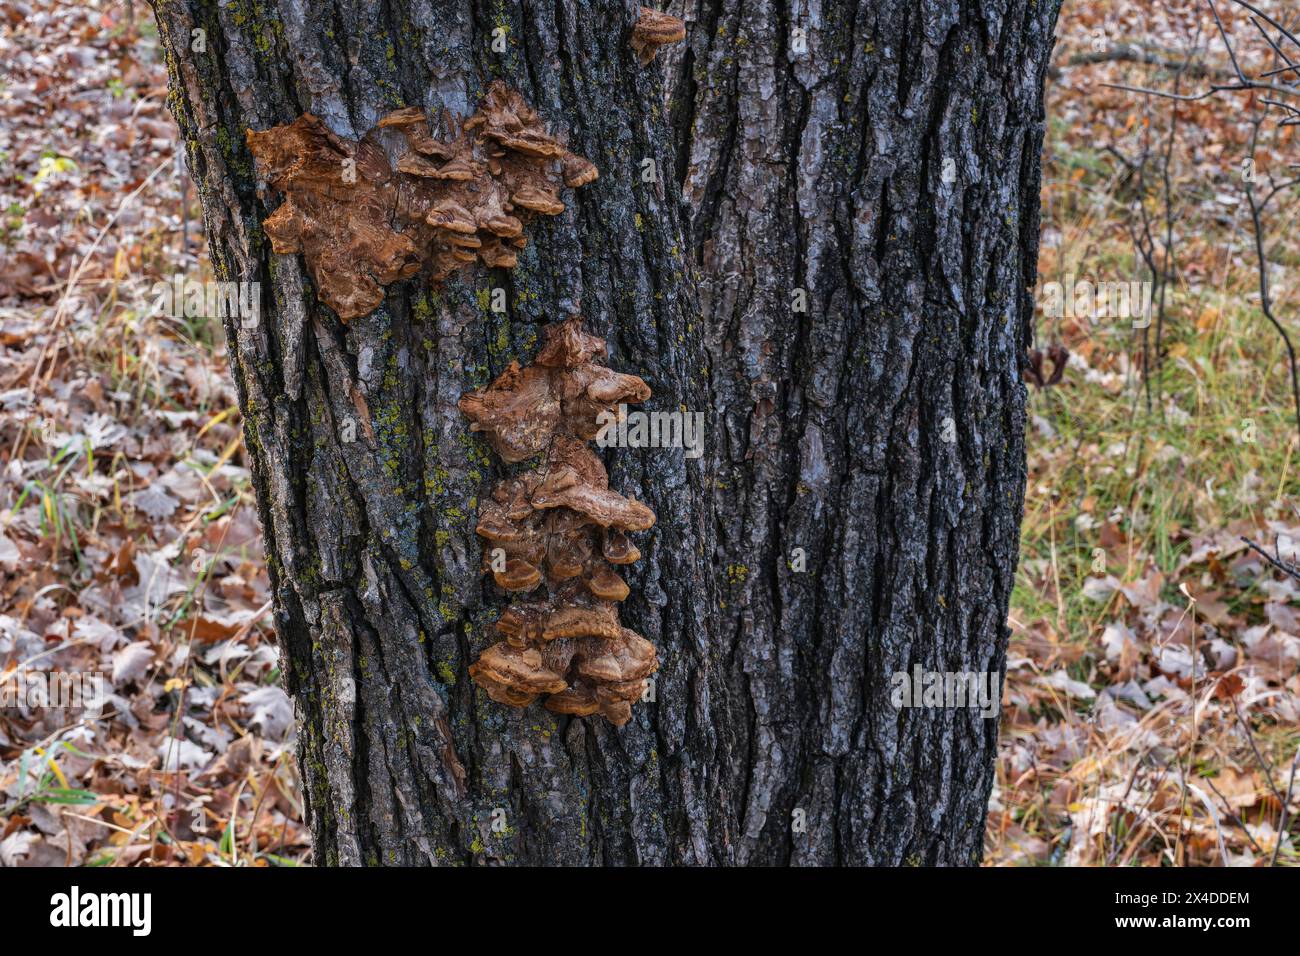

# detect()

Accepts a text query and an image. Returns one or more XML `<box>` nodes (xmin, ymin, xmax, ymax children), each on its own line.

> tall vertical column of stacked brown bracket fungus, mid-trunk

<box><xmin>460</xmin><ymin>316</ymin><xmax>659</xmax><ymax>726</ymax></box>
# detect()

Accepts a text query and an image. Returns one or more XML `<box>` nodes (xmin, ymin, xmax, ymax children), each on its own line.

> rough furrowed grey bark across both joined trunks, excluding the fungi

<box><xmin>153</xmin><ymin>0</ymin><xmax>1058</xmax><ymax>864</ymax></box>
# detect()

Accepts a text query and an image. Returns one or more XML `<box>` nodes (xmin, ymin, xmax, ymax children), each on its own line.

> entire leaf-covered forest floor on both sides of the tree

<box><xmin>0</xmin><ymin>0</ymin><xmax>1300</xmax><ymax>866</ymax></box>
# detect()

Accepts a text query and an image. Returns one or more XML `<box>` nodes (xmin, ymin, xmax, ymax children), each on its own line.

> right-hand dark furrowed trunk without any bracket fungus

<box><xmin>670</xmin><ymin>0</ymin><xmax>1060</xmax><ymax>865</ymax></box>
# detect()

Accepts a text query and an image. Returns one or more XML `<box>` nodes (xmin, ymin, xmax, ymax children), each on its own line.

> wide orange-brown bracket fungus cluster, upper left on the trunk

<box><xmin>247</xmin><ymin>81</ymin><xmax>597</xmax><ymax>321</ymax></box>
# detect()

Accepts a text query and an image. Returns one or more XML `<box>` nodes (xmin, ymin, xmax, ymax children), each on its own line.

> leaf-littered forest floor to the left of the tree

<box><xmin>0</xmin><ymin>0</ymin><xmax>309</xmax><ymax>865</ymax></box>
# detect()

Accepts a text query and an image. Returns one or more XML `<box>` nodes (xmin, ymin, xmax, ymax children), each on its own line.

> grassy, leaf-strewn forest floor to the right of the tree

<box><xmin>987</xmin><ymin>0</ymin><xmax>1300</xmax><ymax>866</ymax></box>
